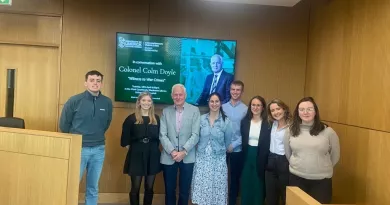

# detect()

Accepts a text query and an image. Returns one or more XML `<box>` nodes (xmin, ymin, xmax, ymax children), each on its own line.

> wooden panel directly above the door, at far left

<box><xmin>0</xmin><ymin>13</ymin><xmax>61</xmax><ymax>46</ymax></box>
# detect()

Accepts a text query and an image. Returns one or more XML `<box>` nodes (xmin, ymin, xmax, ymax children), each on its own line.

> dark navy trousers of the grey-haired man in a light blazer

<box><xmin>163</xmin><ymin>161</ymin><xmax>194</xmax><ymax>205</ymax></box>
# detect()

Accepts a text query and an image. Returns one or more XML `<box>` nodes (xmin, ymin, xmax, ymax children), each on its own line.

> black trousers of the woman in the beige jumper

<box><xmin>290</xmin><ymin>174</ymin><xmax>332</xmax><ymax>204</ymax></box>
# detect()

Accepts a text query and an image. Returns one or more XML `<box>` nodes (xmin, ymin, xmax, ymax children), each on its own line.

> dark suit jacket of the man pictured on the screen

<box><xmin>196</xmin><ymin>71</ymin><xmax>234</xmax><ymax>105</ymax></box>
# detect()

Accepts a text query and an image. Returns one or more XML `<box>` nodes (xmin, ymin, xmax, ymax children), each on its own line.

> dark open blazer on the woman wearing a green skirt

<box><xmin>241</xmin><ymin>118</ymin><xmax>271</xmax><ymax>179</ymax></box>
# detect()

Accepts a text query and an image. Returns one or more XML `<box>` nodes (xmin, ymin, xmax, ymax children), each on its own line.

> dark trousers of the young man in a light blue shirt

<box><xmin>226</xmin><ymin>152</ymin><xmax>244</xmax><ymax>205</ymax></box>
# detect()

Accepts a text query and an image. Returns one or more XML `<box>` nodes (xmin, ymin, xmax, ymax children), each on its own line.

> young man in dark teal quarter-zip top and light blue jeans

<box><xmin>60</xmin><ymin>70</ymin><xmax>112</xmax><ymax>205</ymax></box>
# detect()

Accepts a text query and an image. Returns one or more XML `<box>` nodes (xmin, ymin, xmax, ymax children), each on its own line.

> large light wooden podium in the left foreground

<box><xmin>0</xmin><ymin>127</ymin><xmax>81</xmax><ymax>205</ymax></box>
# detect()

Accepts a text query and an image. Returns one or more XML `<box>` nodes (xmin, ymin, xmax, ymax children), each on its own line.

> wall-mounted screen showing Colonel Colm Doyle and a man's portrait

<box><xmin>115</xmin><ymin>33</ymin><xmax>237</xmax><ymax>106</ymax></box>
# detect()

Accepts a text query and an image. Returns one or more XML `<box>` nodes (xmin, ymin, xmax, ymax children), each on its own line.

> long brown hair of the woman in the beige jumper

<box><xmin>290</xmin><ymin>97</ymin><xmax>326</xmax><ymax>137</ymax></box>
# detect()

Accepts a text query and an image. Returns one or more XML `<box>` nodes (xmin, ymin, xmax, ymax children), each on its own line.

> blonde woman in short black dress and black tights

<box><xmin>121</xmin><ymin>92</ymin><xmax>161</xmax><ymax>205</ymax></box>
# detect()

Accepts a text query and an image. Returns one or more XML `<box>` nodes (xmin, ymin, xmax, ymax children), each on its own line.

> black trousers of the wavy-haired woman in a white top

<box><xmin>265</xmin><ymin>152</ymin><xmax>290</xmax><ymax>205</ymax></box>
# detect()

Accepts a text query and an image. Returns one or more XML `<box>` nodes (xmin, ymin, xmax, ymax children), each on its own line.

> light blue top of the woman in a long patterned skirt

<box><xmin>197</xmin><ymin>113</ymin><xmax>233</xmax><ymax>154</ymax></box>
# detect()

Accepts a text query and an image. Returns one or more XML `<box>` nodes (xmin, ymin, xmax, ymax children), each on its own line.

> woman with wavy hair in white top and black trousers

<box><xmin>265</xmin><ymin>99</ymin><xmax>291</xmax><ymax>205</ymax></box>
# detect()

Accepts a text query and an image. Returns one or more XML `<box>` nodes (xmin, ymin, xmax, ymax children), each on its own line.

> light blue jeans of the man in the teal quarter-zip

<box><xmin>80</xmin><ymin>145</ymin><xmax>105</xmax><ymax>205</ymax></box>
